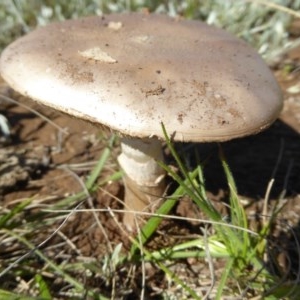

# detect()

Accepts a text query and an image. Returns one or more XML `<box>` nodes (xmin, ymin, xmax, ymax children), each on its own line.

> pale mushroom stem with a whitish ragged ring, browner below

<box><xmin>118</xmin><ymin>137</ymin><xmax>166</xmax><ymax>230</ymax></box>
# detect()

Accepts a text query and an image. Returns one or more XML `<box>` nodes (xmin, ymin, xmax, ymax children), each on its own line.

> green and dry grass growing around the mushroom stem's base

<box><xmin>0</xmin><ymin>127</ymin><xmax>300</xmax><ymax>299</ymax></box>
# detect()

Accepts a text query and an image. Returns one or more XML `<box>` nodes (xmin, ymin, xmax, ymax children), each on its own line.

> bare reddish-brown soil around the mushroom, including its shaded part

<box><xmin>0</xmin><ymin>25</ymin><xmax>300</xmax><ymax>299</ymax></box>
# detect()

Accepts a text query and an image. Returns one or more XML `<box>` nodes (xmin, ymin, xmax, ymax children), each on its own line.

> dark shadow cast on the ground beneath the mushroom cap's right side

<box><xmin>178</xmin><ymin>120</ymin><xmax>300</xmax><ymax>199</ymax></box>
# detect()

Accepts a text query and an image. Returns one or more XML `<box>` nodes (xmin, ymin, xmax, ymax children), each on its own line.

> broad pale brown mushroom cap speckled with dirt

<box><xmin>0</xmin><ymin>13</ymin><xmax>282</xmax><ymax>142</ymax></box>
